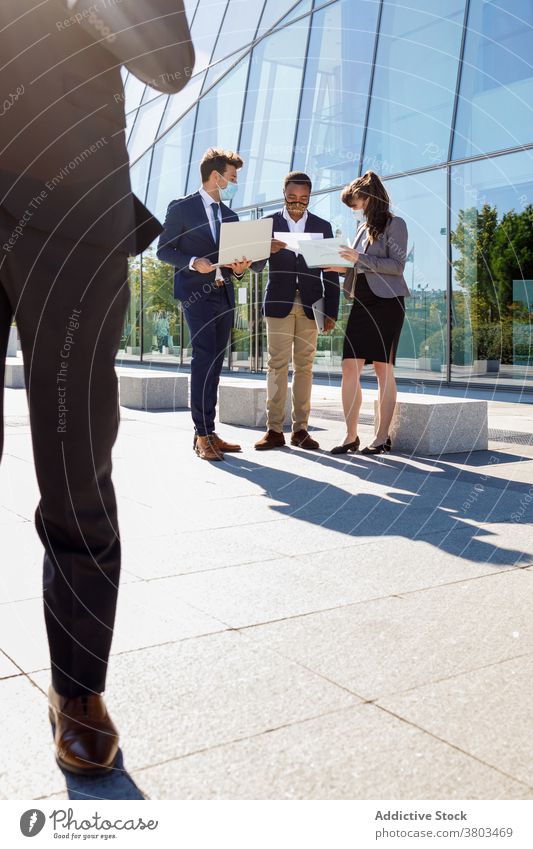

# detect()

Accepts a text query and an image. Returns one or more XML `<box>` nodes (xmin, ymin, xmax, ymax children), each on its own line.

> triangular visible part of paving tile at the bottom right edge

<box><xmin>379</xmin><ymin>654</ymin><xmax>533</xmax><ymax>787</ymax></box>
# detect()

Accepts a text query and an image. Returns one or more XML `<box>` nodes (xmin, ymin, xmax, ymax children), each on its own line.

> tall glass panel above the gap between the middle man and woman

<box><xmin>294</xmin><ymin>0</ymin><xmax>379</xmax><ymax>189</ymax></box>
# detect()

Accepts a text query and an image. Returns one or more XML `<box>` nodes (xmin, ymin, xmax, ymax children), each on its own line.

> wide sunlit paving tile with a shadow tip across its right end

<box><xmin>161</xmin><ymin>531</ymin><xmax>516</xmax><ymax>628</ymax></box>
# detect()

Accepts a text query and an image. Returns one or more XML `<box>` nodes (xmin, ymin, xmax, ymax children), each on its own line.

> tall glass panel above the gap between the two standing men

<box><xmin>235</xmin><ymin>18</ymin><xmax>309</xmax><ymax>206</ymax></box>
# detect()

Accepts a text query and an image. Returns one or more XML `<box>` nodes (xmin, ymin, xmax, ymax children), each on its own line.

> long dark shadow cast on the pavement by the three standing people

<box><xmin>213</xmin><ymin>449</ymin><xmax>533</xmax><ymax>566</ymax></box>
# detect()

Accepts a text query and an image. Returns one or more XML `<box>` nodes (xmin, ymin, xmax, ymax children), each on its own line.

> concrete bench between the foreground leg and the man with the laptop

<box><xmin>119</xmin><ymin>371</ymin><xmax>189</xmax><ymax>410</ymax></box>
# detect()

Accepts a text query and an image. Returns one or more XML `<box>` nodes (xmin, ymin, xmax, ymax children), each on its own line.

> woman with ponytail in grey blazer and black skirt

<box><xmin>327</xmin><ymin>171</ymin><xmax>409</xmax><ymax>454</ymax></box>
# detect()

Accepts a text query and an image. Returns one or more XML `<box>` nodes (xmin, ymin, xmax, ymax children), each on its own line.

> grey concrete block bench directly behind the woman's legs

<box><xmin>374</xmin><ymin>395</ymin><xmax>488</xmax><ymax>455</ymax></box>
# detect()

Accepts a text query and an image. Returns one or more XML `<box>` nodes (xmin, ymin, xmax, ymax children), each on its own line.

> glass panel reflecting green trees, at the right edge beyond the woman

<box><xmin>451</xmin><ymin>151</ymin><xmax>533</xmax><ymax>384</ymax></box>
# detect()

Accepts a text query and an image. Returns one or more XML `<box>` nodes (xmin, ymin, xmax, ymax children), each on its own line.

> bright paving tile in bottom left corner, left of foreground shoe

<box><xmin>0</xmin><ymin>676</ymin><xmax>65</xmax><ymax>799</ymax></box>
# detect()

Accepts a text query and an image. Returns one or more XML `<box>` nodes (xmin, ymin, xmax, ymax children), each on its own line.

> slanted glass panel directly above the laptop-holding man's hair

<box><xmin>187</xmin><ymin>59</ymin><xmax>248</xmax><ymax>192</ymax></box>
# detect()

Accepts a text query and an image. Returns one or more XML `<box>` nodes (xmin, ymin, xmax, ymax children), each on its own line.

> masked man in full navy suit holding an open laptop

<box><xmin>157</xmin><ymin>148</ymin><xmax>251</xmax><ymax>460</ymax></box>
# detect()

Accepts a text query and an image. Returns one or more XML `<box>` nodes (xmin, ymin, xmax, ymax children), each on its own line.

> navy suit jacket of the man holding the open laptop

<box><xmin>157</xmin><ymin>192</ymin><xmax>239</xmax><ymax>307</ymax></box>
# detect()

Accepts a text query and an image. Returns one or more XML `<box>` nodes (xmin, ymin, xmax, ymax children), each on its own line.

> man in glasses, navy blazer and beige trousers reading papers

<box><xmin>254</xmin><ymin>171</ymin><xmax>340</xmax><ymax>451</ymax></box>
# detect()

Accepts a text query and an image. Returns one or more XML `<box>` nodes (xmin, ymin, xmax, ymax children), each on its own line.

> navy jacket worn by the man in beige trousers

<box><xmin>263</xmin><ymin>212</ymin><xmax>340</xmax><ymax>319</ymax></box>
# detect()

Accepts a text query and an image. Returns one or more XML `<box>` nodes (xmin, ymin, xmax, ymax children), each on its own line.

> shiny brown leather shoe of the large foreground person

<box><xmin>48</xmin><ymin>687</ymin><xmax>118</xmax><ymax>775</ymax></box>
